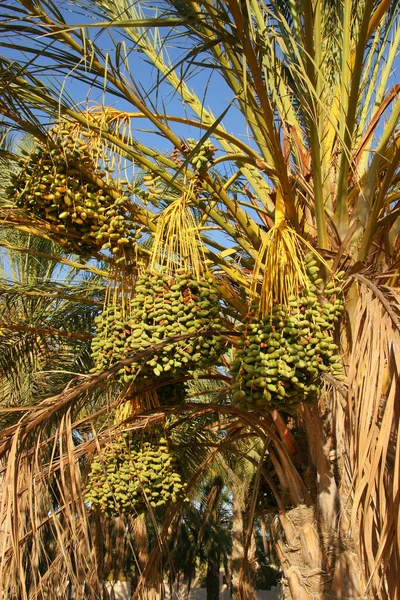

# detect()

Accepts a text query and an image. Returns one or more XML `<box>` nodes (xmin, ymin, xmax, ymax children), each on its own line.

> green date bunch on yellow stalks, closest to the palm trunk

<box><xmin>231</xmin><ymin>195</ymin><xmax>343</xmax><ymax>414</ymax></box>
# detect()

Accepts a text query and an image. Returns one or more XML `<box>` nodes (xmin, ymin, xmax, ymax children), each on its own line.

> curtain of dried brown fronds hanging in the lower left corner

<box><xmin>0</xmin><ymin>388</ymin><xmax>165</xmax><ymax>600</ymax></box>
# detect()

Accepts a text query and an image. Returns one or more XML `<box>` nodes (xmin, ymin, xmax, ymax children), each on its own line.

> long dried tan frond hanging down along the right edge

<box><xmin>337</xmin><ymin>277</ymin><xmax>400</xmax><ymax>600</ymax></box>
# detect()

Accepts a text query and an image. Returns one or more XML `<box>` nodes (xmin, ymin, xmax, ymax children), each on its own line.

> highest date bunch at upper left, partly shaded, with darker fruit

<box><xmin>8</xmin><ymin>121</ymin><xmax>140</xmax><ymax>256</ymax></box>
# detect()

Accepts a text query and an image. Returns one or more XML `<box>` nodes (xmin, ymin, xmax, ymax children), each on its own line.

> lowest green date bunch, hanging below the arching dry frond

<box><xmin>85</xmin><ymin>434</ymin><xmax>186</xmax><ymax>516</ymax></box>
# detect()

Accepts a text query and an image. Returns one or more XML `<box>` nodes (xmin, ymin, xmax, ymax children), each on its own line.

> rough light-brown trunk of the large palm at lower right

<box><xmin>276</xmin><ymin>405</ymin><xmax>364</xmax><ymax>600</ymax></box>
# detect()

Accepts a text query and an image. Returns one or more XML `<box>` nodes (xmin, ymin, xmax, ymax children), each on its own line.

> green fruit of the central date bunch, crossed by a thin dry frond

<box><xmin>120</xmin><ymin>269</ymin><xmax>224</xmax><ymax>382</ymax></box>
